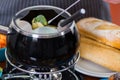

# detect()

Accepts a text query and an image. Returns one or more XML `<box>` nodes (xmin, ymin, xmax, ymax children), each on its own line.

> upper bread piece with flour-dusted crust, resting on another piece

<box><xmin>77</xmin><ymin>17</ymin><xmax>120</xmax><ymax>49</ymax></box>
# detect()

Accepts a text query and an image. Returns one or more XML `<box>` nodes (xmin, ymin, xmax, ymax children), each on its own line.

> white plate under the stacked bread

<box><xmin>75</xmin><ymin>58</ymin><xmax>116</xmax><ymax>78</ymax></box>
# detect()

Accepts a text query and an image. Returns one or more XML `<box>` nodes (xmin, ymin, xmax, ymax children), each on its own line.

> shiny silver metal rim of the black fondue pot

<box><xmin>10</xmin><ymin>5</ymin><xmax>75</xmax><ymax>38</ymax></box>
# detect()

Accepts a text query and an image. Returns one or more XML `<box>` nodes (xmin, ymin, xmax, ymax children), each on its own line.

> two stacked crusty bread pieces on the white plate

<box><xmin>77</xmin><ymin>17</ymin><xmax>120</xmax><ymax>72</ymax></box>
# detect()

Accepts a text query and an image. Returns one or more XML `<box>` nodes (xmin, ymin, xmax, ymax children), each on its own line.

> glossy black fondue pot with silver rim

<box><xmin>1</xmin><ymin>5</ymin><xmax>79</xmax><ymax>67</ymax></box>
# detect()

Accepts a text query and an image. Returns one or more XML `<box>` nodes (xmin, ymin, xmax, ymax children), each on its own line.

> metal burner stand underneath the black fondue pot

<box><xmin>2</xmin><ymin>53</ymin><xmax>81</xmax><ymax>80</ymax></box>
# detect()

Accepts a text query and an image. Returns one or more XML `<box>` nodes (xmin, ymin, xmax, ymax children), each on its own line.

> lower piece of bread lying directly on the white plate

<box><xmin>79</xmin><ymin>35</ymin><xmax>120</xmax><ymax>72</ymax></box>
